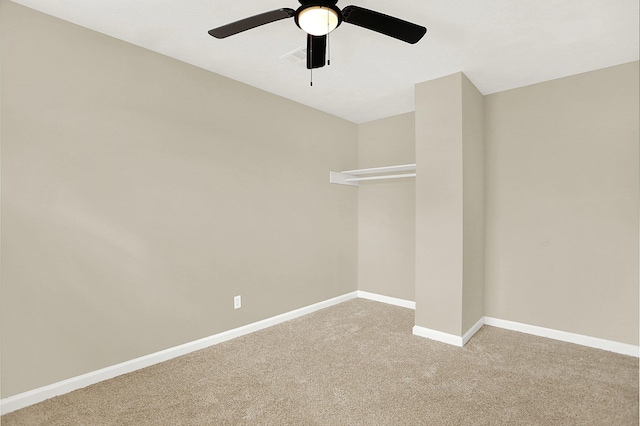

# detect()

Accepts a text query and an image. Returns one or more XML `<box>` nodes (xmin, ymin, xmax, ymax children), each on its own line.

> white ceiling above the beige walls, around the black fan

<box><xmin>14</xmin><ymin>0</ymin><xmax>640</xmax><ymax>123</ymax></box>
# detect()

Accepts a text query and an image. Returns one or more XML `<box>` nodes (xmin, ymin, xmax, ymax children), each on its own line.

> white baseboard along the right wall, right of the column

<box><xmin>484</xmin><ymin>317</ymin><xmax>640</xmax><ymax>358</ymax></box>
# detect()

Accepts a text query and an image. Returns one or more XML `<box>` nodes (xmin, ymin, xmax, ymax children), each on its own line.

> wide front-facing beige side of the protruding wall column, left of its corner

<box><xmin>415</xmin><ymin>73</ymin><xmax>463</xmax><ymax>336</ymax></box>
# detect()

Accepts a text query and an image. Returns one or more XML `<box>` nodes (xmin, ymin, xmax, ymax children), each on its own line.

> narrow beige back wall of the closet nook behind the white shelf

<box><xmin>354</xmin><ymin>113</ymin><xmax>415</xmax><ymax>301</ymax></box>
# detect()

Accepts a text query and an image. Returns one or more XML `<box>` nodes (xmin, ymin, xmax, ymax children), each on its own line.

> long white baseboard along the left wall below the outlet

<box><xmin>0</xmin><ymin>291</ymin><xmax>358</xmax><ymax>414</ymax></box>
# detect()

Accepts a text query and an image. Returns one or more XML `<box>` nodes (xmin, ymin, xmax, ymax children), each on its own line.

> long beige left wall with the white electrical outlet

<box><xmin>0</xmin><ymin>1</ymin><xmax>358</xmax><ymax>397</ymax></box>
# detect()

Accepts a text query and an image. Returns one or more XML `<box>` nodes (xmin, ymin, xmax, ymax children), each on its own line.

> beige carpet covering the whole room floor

<box><xmin>1</xmin><ymin>299</ymin><xmax>638</xmax><ymax>426</ymax></box>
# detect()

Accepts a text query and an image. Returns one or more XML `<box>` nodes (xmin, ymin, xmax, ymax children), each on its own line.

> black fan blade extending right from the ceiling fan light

<box><xmin>342</xmin><ymin>6</ymin><xmax>427</xmax><ymax>44</ymax></box>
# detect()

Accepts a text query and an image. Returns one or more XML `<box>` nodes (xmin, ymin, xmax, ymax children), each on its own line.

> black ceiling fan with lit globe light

<box><xmin>209</xmin><ymin>0</ymin><xmax>427</xmax><ymax>69</ymax></box>
